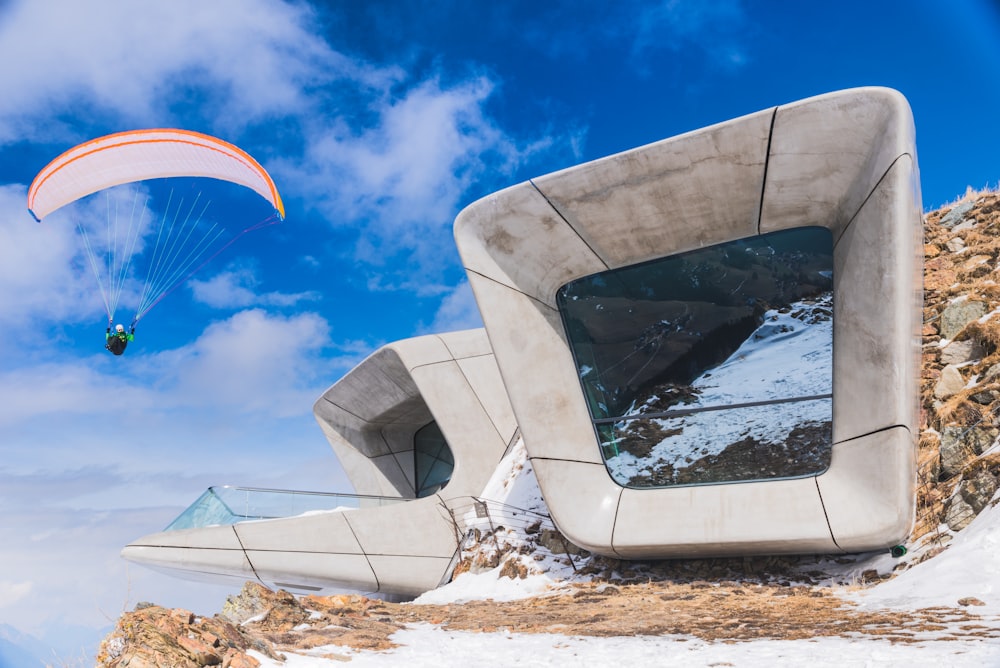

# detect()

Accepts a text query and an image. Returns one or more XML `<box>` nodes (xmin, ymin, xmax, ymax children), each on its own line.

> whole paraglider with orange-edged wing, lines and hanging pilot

<box><xmin>28</xmin><ymin>128</ymin><xmax>285</xmax><ymax>355</ymax></box>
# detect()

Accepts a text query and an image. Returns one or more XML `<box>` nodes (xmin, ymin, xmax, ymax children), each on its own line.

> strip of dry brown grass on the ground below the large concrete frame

<box><xmin>232</xmin><ymin>581</ymin><xmax>1000</xmax><ymax>651</ymax></box>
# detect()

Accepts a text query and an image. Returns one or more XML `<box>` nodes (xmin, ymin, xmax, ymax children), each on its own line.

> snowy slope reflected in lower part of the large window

<box><xmin>599</xmin><ymin>295</ymin><xmax>833</xmax><ymax>487</ymax></box>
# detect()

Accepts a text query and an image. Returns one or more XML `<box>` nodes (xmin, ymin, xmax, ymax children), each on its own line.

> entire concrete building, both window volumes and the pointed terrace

<box><xmin>123</xmin><ymin>88</ymin><xmax>922</xmax><ymax>596</ymax></box>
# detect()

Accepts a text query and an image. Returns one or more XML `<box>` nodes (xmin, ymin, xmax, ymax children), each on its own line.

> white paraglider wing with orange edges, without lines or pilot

<box><xmin>28</xmin><ymin>129</ymin><xmax>285</xmax><ymax>221</ymax></box>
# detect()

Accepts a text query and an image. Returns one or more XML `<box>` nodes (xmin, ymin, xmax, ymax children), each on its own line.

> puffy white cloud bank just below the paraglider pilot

<box><xmin>0</xmin><ymin>309</ymin><xmax>339</xmax><ymax>436</ymax></box>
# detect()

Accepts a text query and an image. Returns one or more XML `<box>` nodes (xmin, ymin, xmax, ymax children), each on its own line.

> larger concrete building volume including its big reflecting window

<box><xmin>455</xmin><ymin>88</ymin><xmax>922</xmax><ymax>558</ymax></box>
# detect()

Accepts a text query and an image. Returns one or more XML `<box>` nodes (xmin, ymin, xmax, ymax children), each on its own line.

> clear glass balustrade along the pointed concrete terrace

<box><xmin>164</xmin><ymin>485</ymin><xmax>412</xmax><ymax>531</ymax></box>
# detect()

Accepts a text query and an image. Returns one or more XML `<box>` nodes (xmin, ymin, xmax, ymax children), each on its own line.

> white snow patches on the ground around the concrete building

<box><xmin>244</xmin><ymin>436</ymin><xmax>1000</xmax><ymax>668</ymax></box>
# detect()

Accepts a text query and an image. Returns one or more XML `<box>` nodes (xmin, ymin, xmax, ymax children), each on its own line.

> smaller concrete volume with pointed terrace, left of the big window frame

<box><xmin>122</xmin><ymin>330</ymin><xmax>517</xmax><ymax>597</ymax></box>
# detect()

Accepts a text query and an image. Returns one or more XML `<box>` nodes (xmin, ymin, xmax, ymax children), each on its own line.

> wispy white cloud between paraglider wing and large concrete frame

<box><xmin>273</xmin><ymin>77</ymin><xmax>549</xmax><ymax>273</ymax></box>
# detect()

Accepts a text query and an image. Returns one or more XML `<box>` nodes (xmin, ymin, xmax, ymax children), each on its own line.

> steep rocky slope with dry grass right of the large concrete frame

<box><xmin>913</xmin><ymin>187</ymin><xmax>1000</xmax><ymax>540</ymax></box>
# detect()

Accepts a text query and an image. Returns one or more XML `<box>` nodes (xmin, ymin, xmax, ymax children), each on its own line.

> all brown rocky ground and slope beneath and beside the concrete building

<box><xmin>97</xmin><ymin>191</ymin><xmax>1000</xmax><ymax>668</ymax></box>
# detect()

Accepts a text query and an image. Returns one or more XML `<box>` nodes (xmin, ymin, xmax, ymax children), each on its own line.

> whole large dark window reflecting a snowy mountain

<box><xmin>556</xmin><ymin>227</ymin><xmax>833</xmax><ymax>487</ymax></box>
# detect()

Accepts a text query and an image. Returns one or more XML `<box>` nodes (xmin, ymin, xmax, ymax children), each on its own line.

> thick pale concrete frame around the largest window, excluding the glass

<box><xmin>455</xmin><ymin>88</ymin><xmax>923</xmax><ymax>558</ymax></box>
